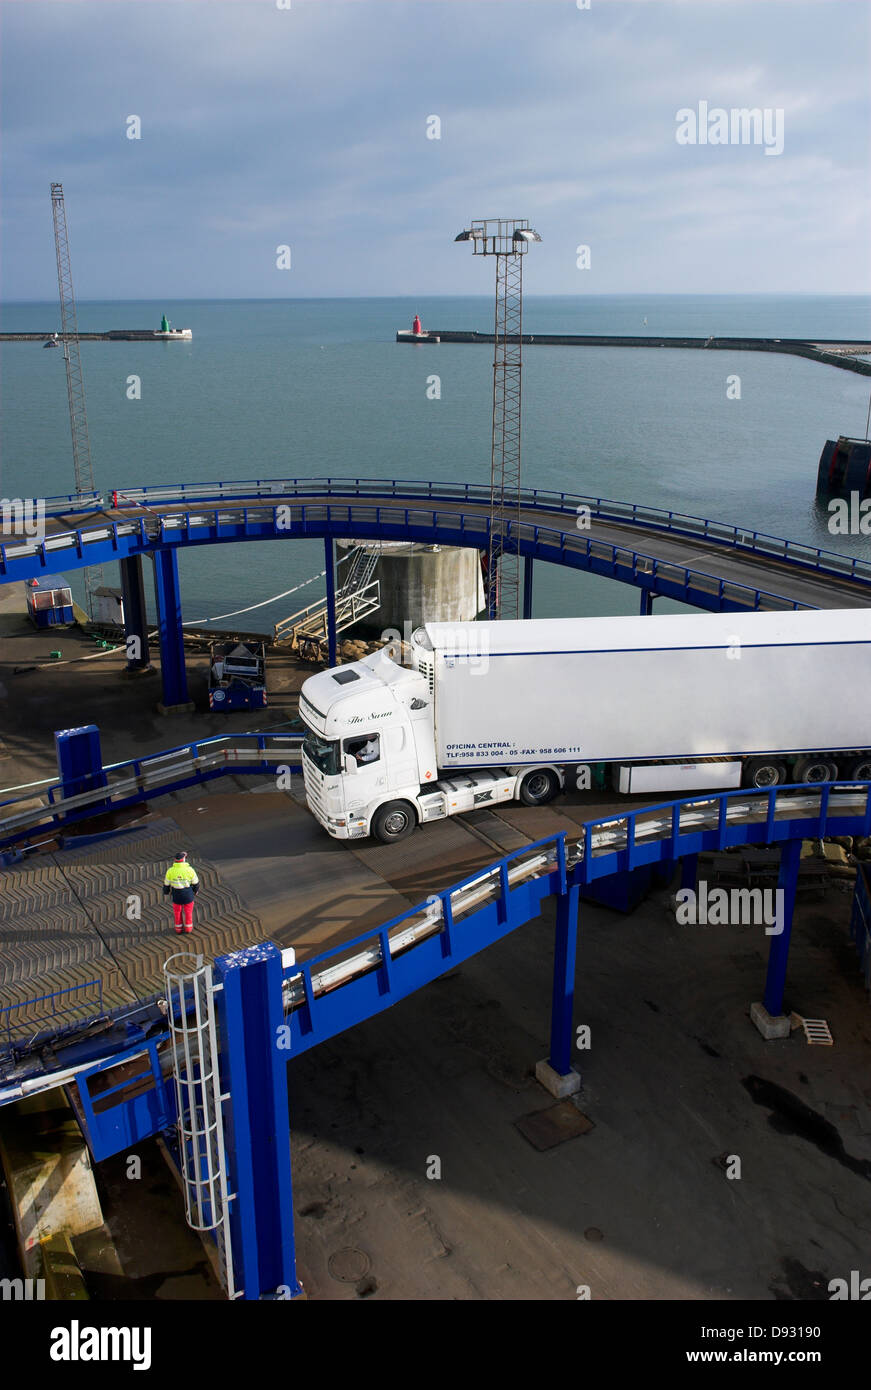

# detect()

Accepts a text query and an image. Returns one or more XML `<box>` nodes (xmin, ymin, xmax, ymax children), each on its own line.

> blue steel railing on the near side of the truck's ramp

<box><xmin>283</xmin><ymin>783</ymin><xmax>871</xmax><ymax>1052</ymax></box>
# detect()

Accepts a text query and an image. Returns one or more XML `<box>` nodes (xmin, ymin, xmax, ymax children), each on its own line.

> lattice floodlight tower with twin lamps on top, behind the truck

<box><xmin>456</xmin><ymin>217</ymin><xmax>542</xmax><ymax>619</ymax></box>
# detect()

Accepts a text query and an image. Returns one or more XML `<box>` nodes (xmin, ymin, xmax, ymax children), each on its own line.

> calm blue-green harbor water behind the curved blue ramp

<box><xmin>0</xmin><ymin>293</ymin><xmax>871</xmax><ymax>632</ymax></box>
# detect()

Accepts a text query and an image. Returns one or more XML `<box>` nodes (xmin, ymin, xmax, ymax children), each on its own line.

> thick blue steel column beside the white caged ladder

<box><xmin>214</xmin><ymin>941</ymin><xmax>303</xmax><ymax>1301</ymax></box>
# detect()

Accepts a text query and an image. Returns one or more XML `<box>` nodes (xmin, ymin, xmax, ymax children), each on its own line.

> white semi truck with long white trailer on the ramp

<box><xmin>300</xmin><ymin>609</ymin><xmax>871</xmax><ymax>842</ymax></box>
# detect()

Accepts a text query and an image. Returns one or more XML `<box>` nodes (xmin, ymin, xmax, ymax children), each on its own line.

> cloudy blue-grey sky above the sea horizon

<box><xmin>0</xmin><ymin>0</ymin><xmax>871</xmax><ymax>300</ymax></box>
